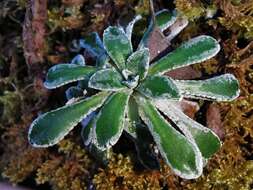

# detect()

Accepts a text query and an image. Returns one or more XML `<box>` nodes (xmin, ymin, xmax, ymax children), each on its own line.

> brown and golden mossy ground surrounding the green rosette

<box><xmin>0</xmin><ymin>0</ymin><xmax>253</xmax><ymax>190</ymax></box>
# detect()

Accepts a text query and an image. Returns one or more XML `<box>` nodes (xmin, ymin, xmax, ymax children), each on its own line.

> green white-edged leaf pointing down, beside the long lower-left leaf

<box><xmin>94</xmin><ymin>91</ymin><xmax>130</xmax><ymax>150</ymax></box>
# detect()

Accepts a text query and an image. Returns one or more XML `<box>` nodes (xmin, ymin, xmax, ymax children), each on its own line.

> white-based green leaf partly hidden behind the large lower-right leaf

<box><xmin>154</xmin><ymin>100</ymin><xmax>221</xmax><ymax>159</ymax></box>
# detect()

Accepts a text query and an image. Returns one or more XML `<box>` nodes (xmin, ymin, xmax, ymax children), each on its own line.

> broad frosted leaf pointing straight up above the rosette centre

<box><xmin>103</xmin><ymin>26</ymin><xmax>133</xmax><ymax>70</ymax></box>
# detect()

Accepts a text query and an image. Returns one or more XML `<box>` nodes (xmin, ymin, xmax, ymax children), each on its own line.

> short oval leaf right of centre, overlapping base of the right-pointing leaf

<box><xmin>137</xmin><ymin>76</ymin><xmax>181</xmax><ymax>100</ymax></box>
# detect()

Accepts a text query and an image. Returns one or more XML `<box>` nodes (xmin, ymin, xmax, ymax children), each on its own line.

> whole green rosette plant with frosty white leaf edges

<box><xmin>28</xmin><ymin>10</ymin><xmax>239</xmax><ymax>179</ymax></box>
